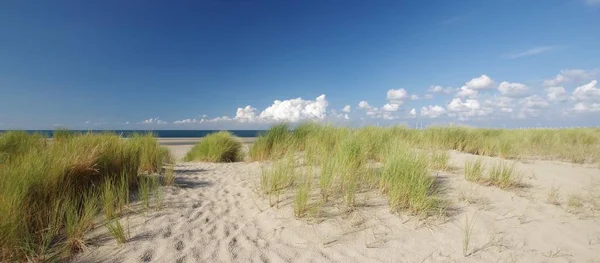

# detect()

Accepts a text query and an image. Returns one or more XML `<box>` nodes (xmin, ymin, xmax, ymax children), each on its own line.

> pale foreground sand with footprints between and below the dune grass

<box><xmin>75</xmin><ymin>145</ymin><xmax>600</xmax><ymax>262</ymax></box>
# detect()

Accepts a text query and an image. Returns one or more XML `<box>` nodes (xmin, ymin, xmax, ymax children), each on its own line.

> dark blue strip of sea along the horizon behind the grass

<box><xmin>0</xmin><ymin>130</ymin><xmax>264</xmax><ymax>138</ymax></box>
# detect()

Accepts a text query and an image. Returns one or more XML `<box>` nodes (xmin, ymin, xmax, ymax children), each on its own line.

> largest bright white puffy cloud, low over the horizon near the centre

<box><xmin>259</xmin><ymin>94</ymin><xmax>328</xmax><ymax>122</ymax></box>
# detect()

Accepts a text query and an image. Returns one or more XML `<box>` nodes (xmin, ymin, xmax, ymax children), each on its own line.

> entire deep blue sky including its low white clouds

<box><xmin>0</xmin><ymin>0</ymin><xmax>600</xmax><ymax>129</ymax></box>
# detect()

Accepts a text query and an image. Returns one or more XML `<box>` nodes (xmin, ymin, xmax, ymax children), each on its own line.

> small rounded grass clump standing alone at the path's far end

<box><xmin>184</xmin><ymin>131</ymin><xmax>244</xmax><ymax>163</ymax></box>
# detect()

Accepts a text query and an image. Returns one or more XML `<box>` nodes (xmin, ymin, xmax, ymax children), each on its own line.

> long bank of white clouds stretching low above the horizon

<box><xmin>139</xmin><ymin>69</ymin><xmax>600</xmax><ymax>128</ymax></box>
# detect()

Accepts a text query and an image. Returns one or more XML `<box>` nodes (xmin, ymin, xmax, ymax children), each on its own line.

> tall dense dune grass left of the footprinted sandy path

<box><xmin>0</xmin><ymin>132</ymin><xmax>171</xmax><ymax>262</ymax></box>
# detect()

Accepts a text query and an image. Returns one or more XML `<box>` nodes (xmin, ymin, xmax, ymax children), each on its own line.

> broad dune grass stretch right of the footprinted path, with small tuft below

<box><xmin>249</xmin><ymin>122</ymin><xmax>600</xmax><ymax>221</ymax></box>
